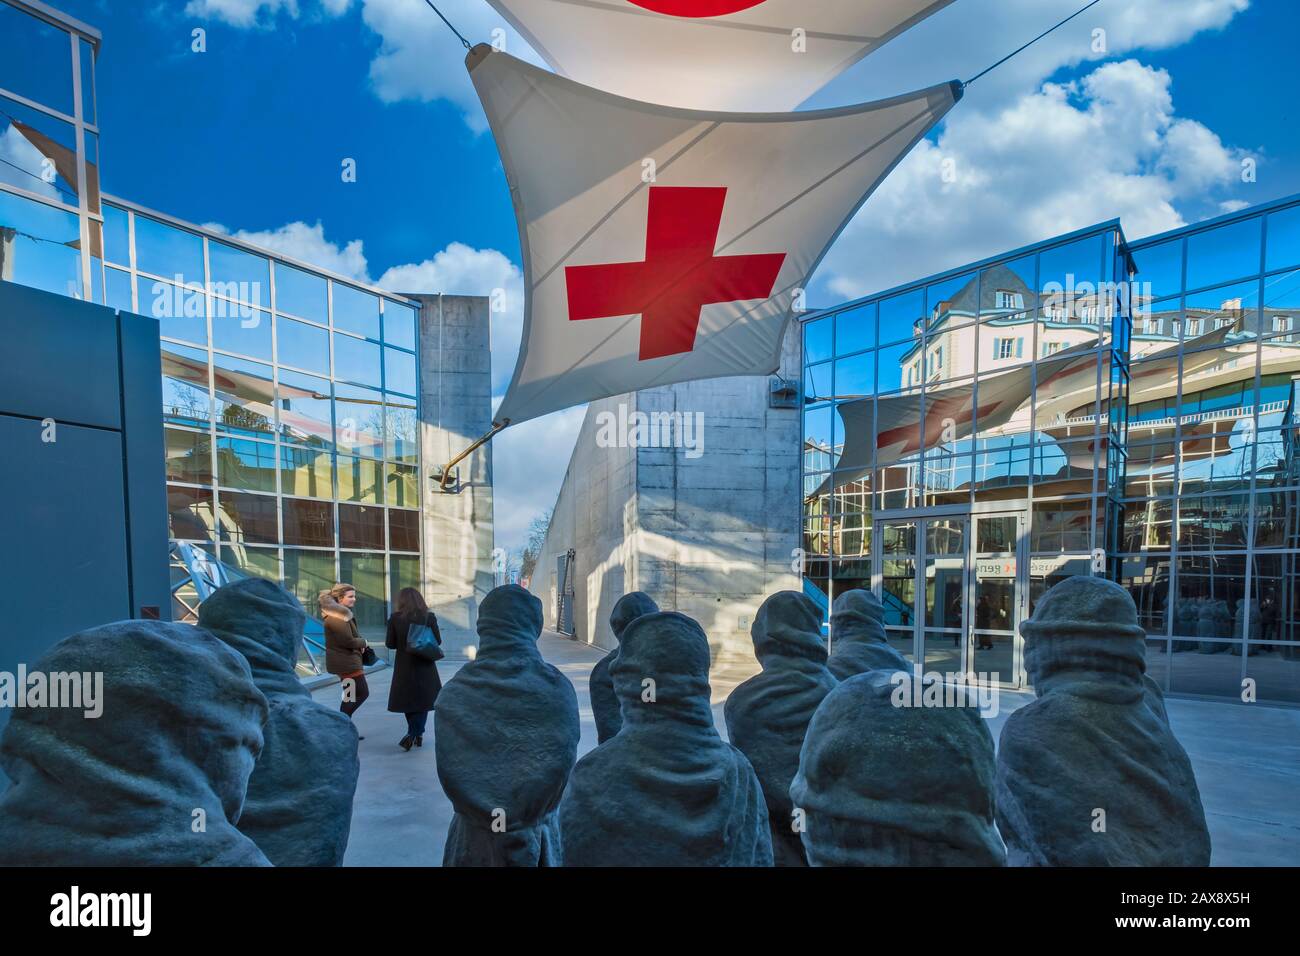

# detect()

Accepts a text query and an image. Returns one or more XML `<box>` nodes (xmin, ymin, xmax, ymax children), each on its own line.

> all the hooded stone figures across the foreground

<box><xmin>0</xmin><ymin>578</ymin><xmax>1210</xmax><ymax>866</ymax></box>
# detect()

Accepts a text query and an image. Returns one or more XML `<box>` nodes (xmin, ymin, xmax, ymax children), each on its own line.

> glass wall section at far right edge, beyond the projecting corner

<box><xmin>1119</xmin><ymin>200</ymin><xmax>1300</xmax><ymax>702</ymax></box>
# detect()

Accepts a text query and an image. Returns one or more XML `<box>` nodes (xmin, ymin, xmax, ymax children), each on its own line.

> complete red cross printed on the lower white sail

<box><xmin>564</xmin><ymin>186</ymin><xmax>785</xmax><ymax>362</ymax></box>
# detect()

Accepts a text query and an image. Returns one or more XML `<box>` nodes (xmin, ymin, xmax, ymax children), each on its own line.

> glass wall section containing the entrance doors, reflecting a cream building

<box><xmin>802</xmin><ymin>224</ymin><xmax>1130</xmax><ymax>684</ymax></box>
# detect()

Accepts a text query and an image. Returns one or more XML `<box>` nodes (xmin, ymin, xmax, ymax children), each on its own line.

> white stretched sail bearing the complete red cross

<box><xmin>467</xmin><ymin>44</ymin><xmax>961</xmax><ymax>423</ymax></box>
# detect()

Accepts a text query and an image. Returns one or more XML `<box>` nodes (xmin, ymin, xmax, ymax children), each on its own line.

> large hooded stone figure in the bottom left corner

<box><xmin>0</xmin><ymin>620</ymin><xmax>270</xmax><ymax>866</ymax></box>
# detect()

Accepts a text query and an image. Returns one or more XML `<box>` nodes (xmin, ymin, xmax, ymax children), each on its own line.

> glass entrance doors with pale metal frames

<box><xmin>876</xmin><ymin>511</ymin><xmax>1024</xmax><ymax>687</ymax></box>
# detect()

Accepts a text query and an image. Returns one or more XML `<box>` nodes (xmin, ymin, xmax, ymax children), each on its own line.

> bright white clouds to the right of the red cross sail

<box><xmin>809</xmin><ymin>0</ymin><xmax>1249</xmax><ymax>304</ymax></box>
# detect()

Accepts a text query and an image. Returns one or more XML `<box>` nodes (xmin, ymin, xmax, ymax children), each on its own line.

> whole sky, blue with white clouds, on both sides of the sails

<box><xmin>45</xmin><ymin>0</ymin><xmax>1300</xmax><ymax>548</ymax></box>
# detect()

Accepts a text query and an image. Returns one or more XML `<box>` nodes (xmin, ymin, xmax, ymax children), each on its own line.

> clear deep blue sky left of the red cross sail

<box><xmin>57</xmin><ymin>0</ymin><xmax>519</xmax><ymax>276</ymax></box>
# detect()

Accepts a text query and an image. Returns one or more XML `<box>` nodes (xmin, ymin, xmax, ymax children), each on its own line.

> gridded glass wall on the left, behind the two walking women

<box><xmin>104</xmin><ymin>200</ymin><xmax>420</xmax><ymax>639</ymax></box>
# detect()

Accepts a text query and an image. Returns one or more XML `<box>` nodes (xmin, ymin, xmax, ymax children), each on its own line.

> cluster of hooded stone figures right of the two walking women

<box><xmin>434</xmin><ymin>578</ymin><xmax>1210</xmax><ymax>866</ymax></box>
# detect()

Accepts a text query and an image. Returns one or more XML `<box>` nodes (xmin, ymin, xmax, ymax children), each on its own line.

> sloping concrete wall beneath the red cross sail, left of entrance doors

<box><xmin>532</xmin><ymin>326</ymin><xmax>801</xmax><ymax>669</ymax></box>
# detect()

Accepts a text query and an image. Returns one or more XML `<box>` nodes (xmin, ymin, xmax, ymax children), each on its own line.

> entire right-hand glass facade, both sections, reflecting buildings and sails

<box><xmin>802</xmin><ymin>198</ymin><xmax>1300</xmax><ymax>701</ymax></box>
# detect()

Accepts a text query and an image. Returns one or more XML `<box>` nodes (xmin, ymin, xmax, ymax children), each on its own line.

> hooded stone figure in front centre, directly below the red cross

<box><xmin>560</xmin><ymin>611</ymin><xmax>772</xmax><ymax>866</ymax></box>
